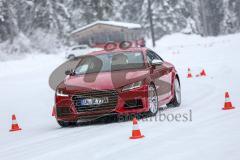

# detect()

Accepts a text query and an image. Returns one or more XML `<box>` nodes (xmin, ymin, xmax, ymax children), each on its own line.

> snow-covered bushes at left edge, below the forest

<box><xmin>0</xmin><ymin>30</ymin><xmax>66</xmax><ymax>62</ymax></box>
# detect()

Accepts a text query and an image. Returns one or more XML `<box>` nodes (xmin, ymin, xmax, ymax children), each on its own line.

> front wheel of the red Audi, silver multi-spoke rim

<box><xmin>148</xmin><ymin>84</ymin><xmax>158</xmax><ymax>116</ymax></box>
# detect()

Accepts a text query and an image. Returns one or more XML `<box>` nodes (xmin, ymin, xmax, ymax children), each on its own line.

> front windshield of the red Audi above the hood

<box><xmin>75</xmin><ymin>52</ymin><xmax>144</xmax><ymax>75</ymax></box>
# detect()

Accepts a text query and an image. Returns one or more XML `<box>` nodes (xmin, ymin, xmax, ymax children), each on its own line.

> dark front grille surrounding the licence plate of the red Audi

<box><xmin>72</xmin><ymin>90</ymin><xmax>118</xmax><ymax>112</ymax></box>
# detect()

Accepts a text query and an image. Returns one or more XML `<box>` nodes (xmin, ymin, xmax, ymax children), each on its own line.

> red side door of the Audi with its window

<box><xmin>147</xmin><ymin>50</ymin><xmax>172</xmax><ymax>101</ymax></box>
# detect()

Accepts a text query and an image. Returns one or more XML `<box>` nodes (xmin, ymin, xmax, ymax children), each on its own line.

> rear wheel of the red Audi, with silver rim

<box><xmin>167</xmin><ymin>77</ymin><xmax>181</xmax><ymax>108</ymax></box>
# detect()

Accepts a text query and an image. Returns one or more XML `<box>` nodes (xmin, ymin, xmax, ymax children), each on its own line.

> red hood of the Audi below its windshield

<box><xmin>64</xmin><ymin>69</ymin><xmax>149</xmax><ymax>90</ymax></box>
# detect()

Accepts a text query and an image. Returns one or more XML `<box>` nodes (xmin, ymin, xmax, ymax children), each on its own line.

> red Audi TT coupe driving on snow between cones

<box><xmin>54</xmin><ymin>48</ymin><xmax>181</xmax><ymax>127</ymax></box>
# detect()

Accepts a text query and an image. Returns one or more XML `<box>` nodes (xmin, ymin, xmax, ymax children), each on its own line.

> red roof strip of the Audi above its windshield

<box><xmin>88</xmin><ymin>47</ymin><xmax>148</xmax><ymax>55</ymax></box>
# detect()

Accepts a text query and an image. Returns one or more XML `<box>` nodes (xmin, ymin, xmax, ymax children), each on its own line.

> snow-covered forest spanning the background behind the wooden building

<box><xmin>0</xmin><ymin>0</ymin><xmax>240</xmax><ymax>52</ymax></box>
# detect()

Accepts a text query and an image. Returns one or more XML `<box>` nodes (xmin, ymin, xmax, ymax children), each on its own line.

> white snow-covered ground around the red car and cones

<box><xmin>0</xmin><ymin>34</ymin><xmax>240</xmax><ymax>160</ymax></box>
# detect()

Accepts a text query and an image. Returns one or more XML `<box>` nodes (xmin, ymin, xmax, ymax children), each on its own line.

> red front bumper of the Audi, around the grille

<box><xmin>55</xmin><ymin>85</ymin><xmax>148</xmax><ymax>121</ymax></box>
